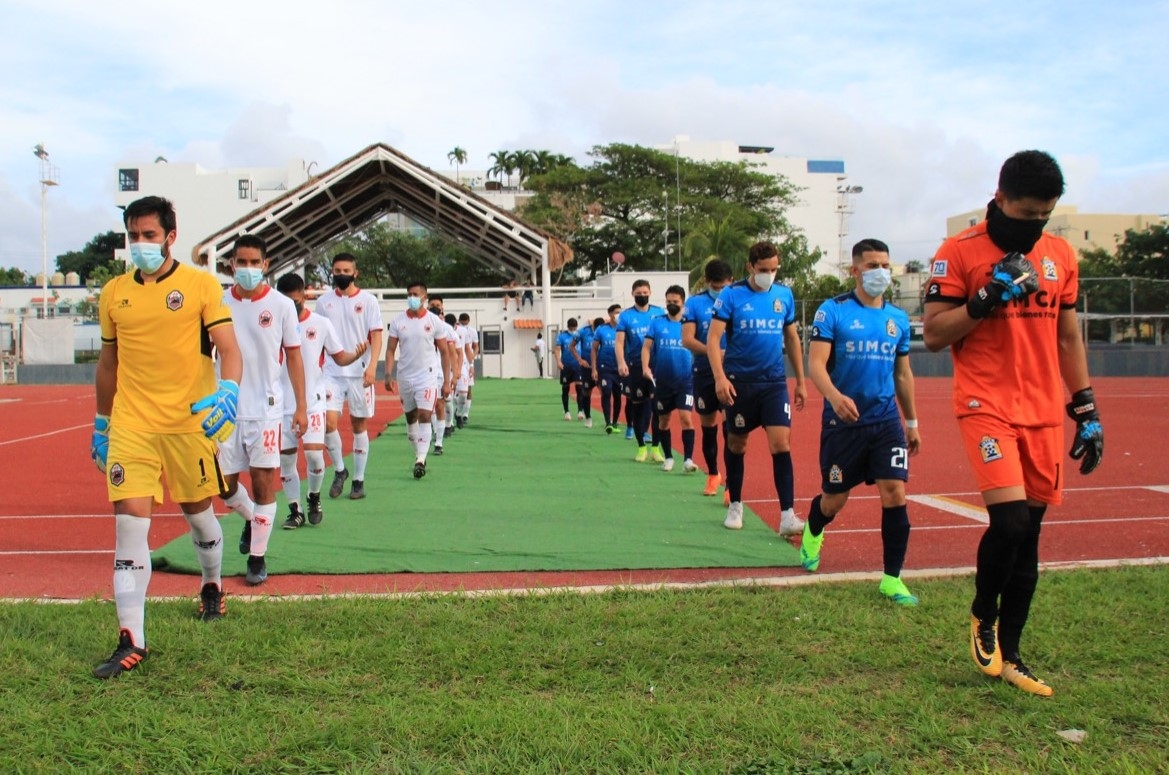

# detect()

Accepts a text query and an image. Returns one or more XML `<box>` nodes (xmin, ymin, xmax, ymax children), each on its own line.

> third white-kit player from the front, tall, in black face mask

<box><xmin>316</xmin><ymin>252</ymin><xmax>382</xmax><ymax>499</ymax></box>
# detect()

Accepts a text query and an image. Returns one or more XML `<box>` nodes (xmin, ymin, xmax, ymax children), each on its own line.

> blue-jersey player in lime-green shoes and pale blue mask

<box><xmin>800</xmin><ymin>240</ymin><xmax>921</xmax><ymax>606</ymax></box>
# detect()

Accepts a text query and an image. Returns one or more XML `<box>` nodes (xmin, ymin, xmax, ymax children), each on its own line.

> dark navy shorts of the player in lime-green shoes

<box><xmin>819</xmin><ymin>417</ymin><xmax>909</xmax><ymax>493</ymax></box>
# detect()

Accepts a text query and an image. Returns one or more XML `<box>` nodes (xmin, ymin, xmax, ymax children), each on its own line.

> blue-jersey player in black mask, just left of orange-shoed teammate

<box><xmin>642</xmin><ymin>285</ymin><xmax>698</xmax><ymax>473</ymax></box>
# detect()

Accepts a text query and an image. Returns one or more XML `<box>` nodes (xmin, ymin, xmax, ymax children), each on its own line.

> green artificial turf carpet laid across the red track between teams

<box><xmin>154</xmin><ymin>379</ymin><xmax>800</xmax><ymax>574</ymax></box>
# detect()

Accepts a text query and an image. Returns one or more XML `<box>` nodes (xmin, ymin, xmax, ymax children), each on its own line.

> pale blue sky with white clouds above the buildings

<box><xmin>0</xmin><ymin>0</ymin><xmax>1169</xmax><ymax>271</ymax></box>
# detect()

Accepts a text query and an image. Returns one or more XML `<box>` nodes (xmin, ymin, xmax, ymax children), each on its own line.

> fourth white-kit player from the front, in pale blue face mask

<box><xmin>386</xmin><ymin>282</ymin><xmax>450</xmax><ymax>479</ymax></box>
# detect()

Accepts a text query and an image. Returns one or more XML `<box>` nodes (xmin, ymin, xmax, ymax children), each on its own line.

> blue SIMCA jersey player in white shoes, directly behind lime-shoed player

<box><xmin>706</xmin><ymin>242</ymin><xmax>808</xmax><ymax>535</ymax></box>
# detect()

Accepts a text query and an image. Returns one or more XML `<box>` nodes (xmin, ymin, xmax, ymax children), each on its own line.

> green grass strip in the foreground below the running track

<box><xmin>0</xmin><ymin>567</ymin><xmax>1169</xmax><ymax>774</ymax></box>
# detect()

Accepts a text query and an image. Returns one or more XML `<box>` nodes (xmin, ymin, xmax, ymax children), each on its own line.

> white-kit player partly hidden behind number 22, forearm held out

<box><xmin>276</xmin><ymin>274</ymin><xmax>368</xmax><ymax>530</ymax></box>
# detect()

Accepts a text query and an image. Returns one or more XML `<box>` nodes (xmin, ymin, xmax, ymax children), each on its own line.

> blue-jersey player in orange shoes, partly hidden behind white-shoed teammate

<box><xmin>682</xmin><ymin>258</ymin><xmax>734</xmax><ymax>496</ymax></box>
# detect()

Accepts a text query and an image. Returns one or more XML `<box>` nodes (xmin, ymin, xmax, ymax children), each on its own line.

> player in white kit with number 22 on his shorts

<box><xmin>219</xmin><ymin>234</ymin><xmax>307</xmax><ymax>584</ymax></box>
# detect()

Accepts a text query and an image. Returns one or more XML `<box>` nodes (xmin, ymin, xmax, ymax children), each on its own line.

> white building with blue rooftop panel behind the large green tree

<box><xmin>655</xmin><ymin>134</ymin><xmax>860</xmax><ymax>275</ymax></box>
